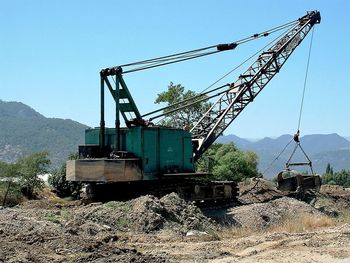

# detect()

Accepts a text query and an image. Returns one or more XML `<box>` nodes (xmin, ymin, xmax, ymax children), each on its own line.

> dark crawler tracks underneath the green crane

<box><xmin>86</xmin><ymin>179</ymin><xmax>238</xmax><ymax>207</ymax></box>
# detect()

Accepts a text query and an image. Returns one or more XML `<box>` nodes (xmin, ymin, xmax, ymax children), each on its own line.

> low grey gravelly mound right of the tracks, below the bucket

<box><xmin>227</xmin><ymin>197</ymin><xmax>321</xmax><ymax>229</ymax></box>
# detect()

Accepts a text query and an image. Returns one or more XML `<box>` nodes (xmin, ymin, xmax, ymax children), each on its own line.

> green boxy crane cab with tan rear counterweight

<box><xmin>67</xmin><ymin>126</ymin><xmax>195</xmax><ymax>182</ymax></box>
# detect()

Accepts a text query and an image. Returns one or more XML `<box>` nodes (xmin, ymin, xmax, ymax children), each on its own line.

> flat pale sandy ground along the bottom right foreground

<box><xmin>132</xmin><ymin>225</ymin><xmax>350</xmax><ymax>263</ymax></box>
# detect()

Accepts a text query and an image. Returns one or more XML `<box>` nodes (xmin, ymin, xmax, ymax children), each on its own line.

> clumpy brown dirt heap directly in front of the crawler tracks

<box><xmin>73</xmin><ymin>193</ymin><xmax>215</xmax><ymax>234</ymax></box>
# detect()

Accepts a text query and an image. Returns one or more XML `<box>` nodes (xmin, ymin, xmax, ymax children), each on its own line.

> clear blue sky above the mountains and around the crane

<box><xmin>0</xmin><ymin>0</ymin><xmax>350</xmax><ymax>138</ymax></box>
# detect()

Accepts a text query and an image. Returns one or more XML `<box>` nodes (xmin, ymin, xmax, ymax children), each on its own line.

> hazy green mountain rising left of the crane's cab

<box><xmin>0</xmin><ymin>100</ymin><xmax>88</xmax><ymax>167</ymax></box>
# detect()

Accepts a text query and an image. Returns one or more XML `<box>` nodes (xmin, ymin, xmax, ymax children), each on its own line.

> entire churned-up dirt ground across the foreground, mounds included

<box><xmin>0</xmin><ymin>182</ymin><xmax>350</xmax><ymax>263</ymax></box>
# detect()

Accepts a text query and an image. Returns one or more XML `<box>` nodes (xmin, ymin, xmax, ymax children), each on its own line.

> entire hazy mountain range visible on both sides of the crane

<box><xmin>0</xmin><ymin>100</ymin><xmax>350</xmax><ymax>177</ymax></box>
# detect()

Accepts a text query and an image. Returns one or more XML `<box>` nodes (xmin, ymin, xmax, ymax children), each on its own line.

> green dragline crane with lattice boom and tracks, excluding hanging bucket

<box><xmin>67</xmin><ymin>11</ymin><xmax>321</xmax><ymax>201</ymax></box>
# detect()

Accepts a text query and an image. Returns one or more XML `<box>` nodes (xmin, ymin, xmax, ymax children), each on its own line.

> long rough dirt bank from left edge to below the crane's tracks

<box><xmin>0</xmin><ymin>194</ymin><xmax>215</xmax><ymax>263</ymax></box>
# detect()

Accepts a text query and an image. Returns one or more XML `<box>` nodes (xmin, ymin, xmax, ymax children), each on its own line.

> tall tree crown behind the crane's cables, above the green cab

<box><xmin>155</xmin><ymin>82</ymin><xmax>210</xmax><ymax>129</ymax></box>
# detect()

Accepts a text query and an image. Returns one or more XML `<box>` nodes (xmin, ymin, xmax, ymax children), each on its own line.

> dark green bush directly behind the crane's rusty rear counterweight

<box><xmin>48</xmin><ymin>154</ymin><xmax>82</xmax><ymax>199</ymax></box>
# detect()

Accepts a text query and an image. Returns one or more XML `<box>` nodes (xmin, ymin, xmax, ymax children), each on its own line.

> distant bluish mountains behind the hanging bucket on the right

<box><xmin>217</xmin><ymin>133</ymin><xmax>350</xmax><ymax>178</ymax></box>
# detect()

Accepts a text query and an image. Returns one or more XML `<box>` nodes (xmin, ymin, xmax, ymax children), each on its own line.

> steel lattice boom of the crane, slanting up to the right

<box><xmin>191</xmin><ymin>11</ymin><xmax>321</xmax><ymax>160</ymax></box>
